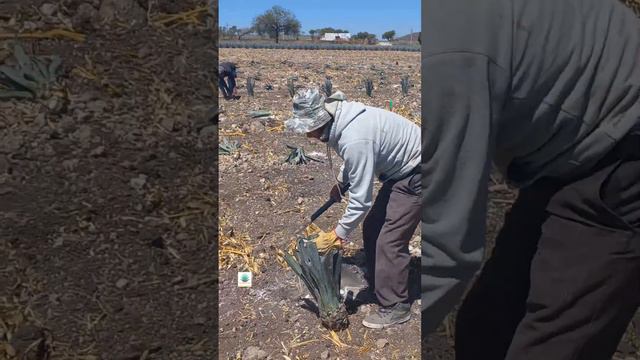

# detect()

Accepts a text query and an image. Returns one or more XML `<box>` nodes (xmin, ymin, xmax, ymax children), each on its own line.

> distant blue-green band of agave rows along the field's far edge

<box><xmin>218</xmin><ymin>41</ymin><xmax>420</xmax><ymax>51</ymax></box>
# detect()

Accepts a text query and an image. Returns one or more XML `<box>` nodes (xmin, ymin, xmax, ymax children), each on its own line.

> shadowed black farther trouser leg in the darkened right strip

<box><xmin>455</xmin><ymin>189</ymin><xmax>549</xmax><ymax>360</ymax></box>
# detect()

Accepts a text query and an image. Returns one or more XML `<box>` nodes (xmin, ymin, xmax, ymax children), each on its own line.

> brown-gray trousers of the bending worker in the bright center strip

<box><xmin>365</xmin><ymin>174</ymin><xmax>422</xmax><ymax>306</ymax></box>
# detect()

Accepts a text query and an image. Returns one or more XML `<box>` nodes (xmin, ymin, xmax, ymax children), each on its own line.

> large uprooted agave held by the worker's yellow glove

<box><xmin>284</xmin><ymin>237</ymin><xmax>349</xmax><ymax>331</ymax></box>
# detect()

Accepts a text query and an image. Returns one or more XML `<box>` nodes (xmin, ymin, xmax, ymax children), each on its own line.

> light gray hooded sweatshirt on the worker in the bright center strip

<box><xmin>327</xmin><ymin>101</ymin><xmax>421</xmax><ymax>239</ymax></box>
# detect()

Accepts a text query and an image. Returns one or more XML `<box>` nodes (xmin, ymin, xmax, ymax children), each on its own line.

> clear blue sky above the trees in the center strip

<box><xmin>218</xmin><ymin>0</ymin><xmax>420</xmax><ymax>38</ymax></box>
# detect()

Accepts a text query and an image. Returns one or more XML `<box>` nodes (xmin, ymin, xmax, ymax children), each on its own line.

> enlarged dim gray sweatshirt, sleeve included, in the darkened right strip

<box><xmin>422</xmin><ymin>0</ymin><xmax>640</xmax><ymax>334</ymax></box>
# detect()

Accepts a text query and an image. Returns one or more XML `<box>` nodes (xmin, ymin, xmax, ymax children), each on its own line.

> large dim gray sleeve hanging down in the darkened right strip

<box><xmin>422</xmin><ymin>52</ymin><xmax>508</xmax><ymax>334</ymax></box>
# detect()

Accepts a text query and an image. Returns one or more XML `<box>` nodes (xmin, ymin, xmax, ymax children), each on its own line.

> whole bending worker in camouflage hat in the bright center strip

<box><xmin>285</xmin><ymin>89</ymin><xmax>421</xmax><ymax>329</ymax></box>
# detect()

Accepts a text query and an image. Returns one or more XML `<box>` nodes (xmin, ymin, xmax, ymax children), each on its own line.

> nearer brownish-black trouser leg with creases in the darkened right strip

<box><xmin>506</xmin><ymin>156</ymin><xmax>640</xmax><ymax>360</ymax></box>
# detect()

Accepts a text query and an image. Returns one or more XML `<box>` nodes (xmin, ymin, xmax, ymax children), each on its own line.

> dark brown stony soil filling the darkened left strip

<box><xmin>0</xmin><ymin>0</ymin><xmax>217</xmax><ymax>359</ymax></box>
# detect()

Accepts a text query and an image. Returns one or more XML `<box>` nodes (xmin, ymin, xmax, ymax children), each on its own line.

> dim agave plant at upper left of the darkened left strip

<box><xmin>0</xmin><ymin>44</ymin><xmax>62</xmax><ymax>99</ymax></box>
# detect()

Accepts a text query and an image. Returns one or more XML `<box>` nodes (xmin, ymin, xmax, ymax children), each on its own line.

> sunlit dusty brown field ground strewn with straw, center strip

<box><xmin>219</xmin><ymin>49</ymin><xmax>420</xmax><ymax>359</ymax></box>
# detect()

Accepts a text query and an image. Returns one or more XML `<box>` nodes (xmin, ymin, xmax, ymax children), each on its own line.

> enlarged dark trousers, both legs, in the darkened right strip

<box><xmin>455</xmin><ymin>129</ymin><xmax>640</xmax><ymax>360</ymax></box>
